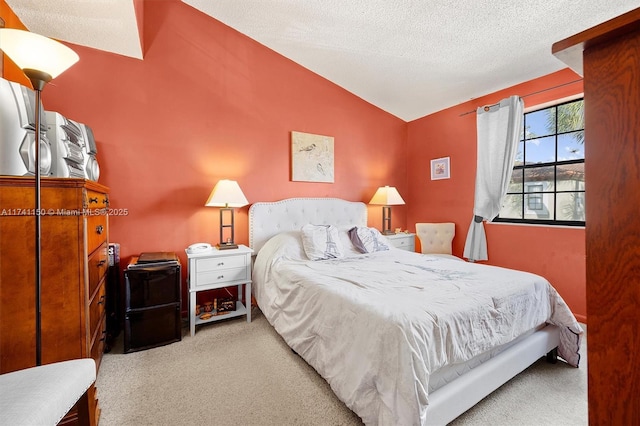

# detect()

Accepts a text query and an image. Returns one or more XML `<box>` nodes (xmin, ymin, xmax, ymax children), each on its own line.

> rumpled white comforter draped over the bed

<box><xmin>253</xmin><ymin>232</ymin><xmax>582</xmax><ymax>425</ymax></box>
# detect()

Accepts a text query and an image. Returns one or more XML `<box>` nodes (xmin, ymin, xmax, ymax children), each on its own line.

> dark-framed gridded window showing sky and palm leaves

<box><xmin>495</xmin><ymin>99</ymin><xmax>585</xmax><ymax>226</ymax></box>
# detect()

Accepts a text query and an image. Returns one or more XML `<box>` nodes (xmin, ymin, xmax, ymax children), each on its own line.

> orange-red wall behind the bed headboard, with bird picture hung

<box><xmin>1</xmin><ymin>0</ymin><xmax>407</xmax><ymax>264</ymax></box>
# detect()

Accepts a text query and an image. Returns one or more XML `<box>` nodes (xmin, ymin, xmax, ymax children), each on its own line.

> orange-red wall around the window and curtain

<box><xmin>405</xmin><ymin>69</ymin><xmax>587</xmax><ymax>322</ymax></box>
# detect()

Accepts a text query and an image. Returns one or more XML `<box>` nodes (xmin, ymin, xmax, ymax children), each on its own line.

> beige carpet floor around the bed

<box><xmin>96</xmin><ymin>308</ymin><xmax>587</xmax><ymax>426</ymax></box>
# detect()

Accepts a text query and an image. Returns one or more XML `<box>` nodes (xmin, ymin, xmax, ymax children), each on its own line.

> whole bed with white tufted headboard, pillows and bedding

<box><xmin>249</xmin><ymin>198</ymin><xmax>582</xmax><ymax>425</ymax></box>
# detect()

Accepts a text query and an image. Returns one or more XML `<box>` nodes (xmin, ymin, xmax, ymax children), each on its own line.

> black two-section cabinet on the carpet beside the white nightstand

<box><xmin>124</xmin><ymin>258</ymin><xmax>182</xmax><ymax>353</ymax></box>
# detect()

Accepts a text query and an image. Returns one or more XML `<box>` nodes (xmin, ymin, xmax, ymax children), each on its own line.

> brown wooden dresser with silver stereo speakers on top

<box><xmin>0</xmin><ymin>176</ymin><xmax>109</xmax><ymax>418</ymax></box>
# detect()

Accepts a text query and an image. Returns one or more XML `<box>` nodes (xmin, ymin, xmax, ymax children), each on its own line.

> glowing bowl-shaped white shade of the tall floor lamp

<box><xmin>0</xmin><ymin>28</ymin><xmax>80</xmax><ymax>78</ymax></box>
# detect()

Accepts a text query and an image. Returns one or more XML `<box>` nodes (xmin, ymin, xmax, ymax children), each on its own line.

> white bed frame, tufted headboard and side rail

<box><xmin>249</xmin><ymin>198</ymin><xmax>560</xmax><ymax>425</ymax></box>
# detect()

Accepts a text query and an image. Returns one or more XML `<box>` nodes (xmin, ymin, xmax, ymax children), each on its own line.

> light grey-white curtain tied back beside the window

<box><xmin>464</xmin><ymin>96</ymin><xmax>524</xmax><ymax>262</ymax></box>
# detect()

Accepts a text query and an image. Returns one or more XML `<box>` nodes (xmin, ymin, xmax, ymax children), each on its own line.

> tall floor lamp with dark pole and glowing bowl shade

<box><xmin>0</xmin><ymin>28</ymin><xmax>79</xmax><ymax>365</ymax></box>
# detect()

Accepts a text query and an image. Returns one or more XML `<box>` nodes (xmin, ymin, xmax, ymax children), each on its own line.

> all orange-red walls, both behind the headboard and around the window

<box><xmin>0</xmin><ymin>0</ymin><xmax>586</xmax><ymax>321</ymax></box>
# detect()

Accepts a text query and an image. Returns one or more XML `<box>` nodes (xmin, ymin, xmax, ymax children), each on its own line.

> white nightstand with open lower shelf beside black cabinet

<box><xmin>187</xmin><ymin>245</ymin><xmax>253</xmax><ymax>336</ymax></box>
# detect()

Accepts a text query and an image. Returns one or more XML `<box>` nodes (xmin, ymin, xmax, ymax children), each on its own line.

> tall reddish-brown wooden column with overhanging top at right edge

<box><xmin>552</xmin><ymin>9</ymin><xmax>640</xmax><ymax>425</ymax></box>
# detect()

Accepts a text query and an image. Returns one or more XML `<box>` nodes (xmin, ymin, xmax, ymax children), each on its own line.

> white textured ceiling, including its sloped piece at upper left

<box><xmin>7</xmin><ymin>0</ymin><xmax>639</xmax><ymax>121</ymax></box>
